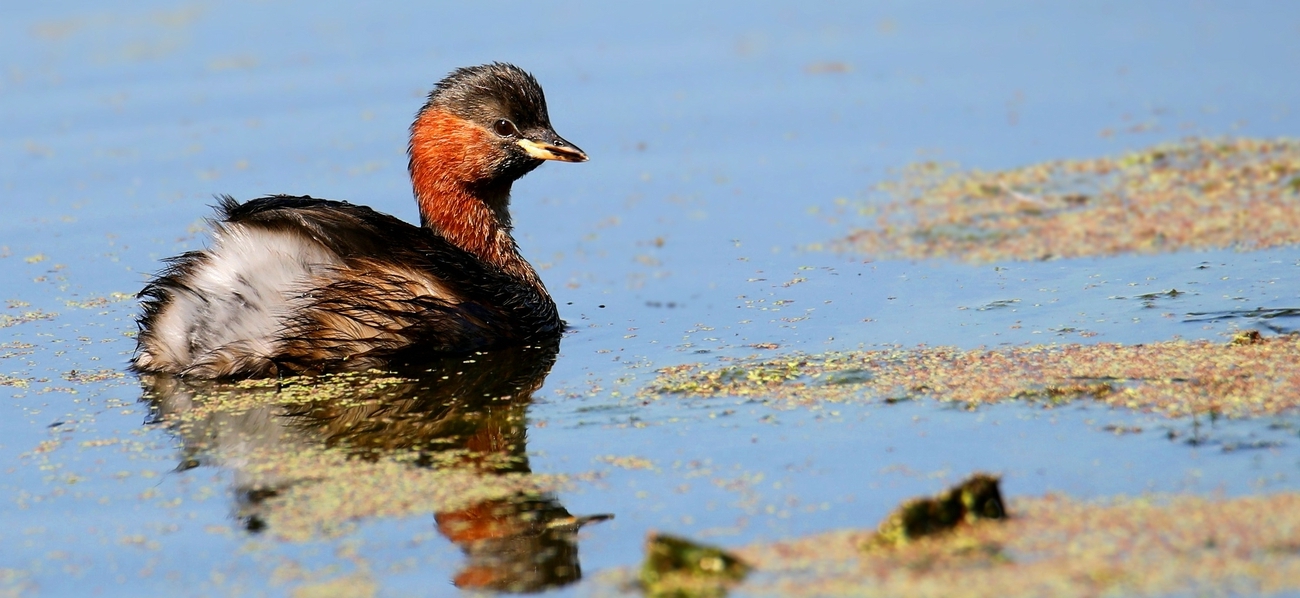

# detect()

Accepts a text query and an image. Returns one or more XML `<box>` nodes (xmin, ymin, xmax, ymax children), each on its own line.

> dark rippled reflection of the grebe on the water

<box><xmin>142</xmin><ymin>343</ymin><xmax>611</xmax><ymax>592</ymax></box>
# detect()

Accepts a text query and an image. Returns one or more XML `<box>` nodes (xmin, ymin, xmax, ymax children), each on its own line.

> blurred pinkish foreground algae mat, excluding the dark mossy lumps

<box><xmin>736</xmin><ymin>493</ymin><xmax>1300</xmax><ymax>597</ymax></box>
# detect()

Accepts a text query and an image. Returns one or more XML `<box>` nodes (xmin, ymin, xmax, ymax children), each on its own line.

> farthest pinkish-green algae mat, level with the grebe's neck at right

<box><xmin>840</xmin><ymin>139</ymin><xmax>1300</xmax><ymax>263</ymax></box>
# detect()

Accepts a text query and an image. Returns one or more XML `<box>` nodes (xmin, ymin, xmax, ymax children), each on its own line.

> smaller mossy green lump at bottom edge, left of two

<box><xmin>641</xmin><ymin>533</ymin><xmax>750</xmax><ymax>598</ymax></box>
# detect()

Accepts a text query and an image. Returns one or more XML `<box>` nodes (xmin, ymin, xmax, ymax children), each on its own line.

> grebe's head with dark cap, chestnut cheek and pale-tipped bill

<box><xmin>410</xmin><ymin>62</ymin><xmax>586</xmax><ymax>187</ymax></box>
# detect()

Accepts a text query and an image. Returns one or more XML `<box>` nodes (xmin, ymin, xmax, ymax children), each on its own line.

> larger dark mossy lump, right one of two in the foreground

<box><xmin>863</xmin><ymin>473</ymin><xmax>1006</xmax><ymax>550</ymax></box>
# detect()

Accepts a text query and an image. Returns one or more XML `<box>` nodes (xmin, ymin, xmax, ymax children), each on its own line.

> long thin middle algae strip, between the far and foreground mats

<box><xmin>642</xmin><ymin>333</ymin><xmax>1300</xmax><ymax>417</ymax></box>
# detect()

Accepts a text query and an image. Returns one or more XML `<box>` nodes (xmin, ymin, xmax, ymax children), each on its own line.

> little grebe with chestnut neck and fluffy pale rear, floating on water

<box><xmin>134</xmin><ymin>64</ymin><xmax>586</xmax><ymax>378</ymax></box>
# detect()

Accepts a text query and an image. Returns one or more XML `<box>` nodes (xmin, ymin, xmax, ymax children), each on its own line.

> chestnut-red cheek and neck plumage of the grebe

<box><xmin>410</xmin><ymin>108</ymin><xmax>540</xmax><ymax>285</ymax></box>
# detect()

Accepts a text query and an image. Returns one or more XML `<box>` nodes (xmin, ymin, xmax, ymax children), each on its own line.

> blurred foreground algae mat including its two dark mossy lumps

<box><xmin>602</xmin><ymin>473</ymin><xmax>1300</xmax><ymax>597</ymax></box>
